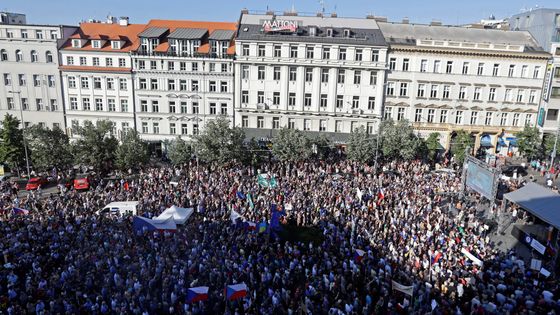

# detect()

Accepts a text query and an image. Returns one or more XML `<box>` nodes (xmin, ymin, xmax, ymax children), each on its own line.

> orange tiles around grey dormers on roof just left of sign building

<box><xmin>139</xmin><ymin>20</ymin><xmax>237</xmax><ymax>55</ymax></box>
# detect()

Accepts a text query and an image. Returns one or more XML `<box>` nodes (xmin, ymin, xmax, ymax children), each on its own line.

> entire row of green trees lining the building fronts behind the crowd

<box><xmin>0</xmin><ymin>114</ymin><xmax>486</xmax><ymax>172</ymax></box>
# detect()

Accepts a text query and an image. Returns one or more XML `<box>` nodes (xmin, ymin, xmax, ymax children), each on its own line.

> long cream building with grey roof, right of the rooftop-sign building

<box><xmin>379</xmin><ymin>22</ymin><xmax>550</xmax><ymax>153</ymax></box>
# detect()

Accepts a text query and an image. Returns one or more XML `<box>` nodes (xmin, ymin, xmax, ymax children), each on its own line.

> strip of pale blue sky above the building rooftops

<box><xmin>0</xmin><ymin>0</ymin><xmax>560</xmax><ymax>24</ymax></box>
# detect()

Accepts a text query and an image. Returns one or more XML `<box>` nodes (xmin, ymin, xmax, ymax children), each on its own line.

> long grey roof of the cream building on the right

<box><xmin>378</xmin><ymin>22</ymin><xmax>542</xmax><ymax>51</ymax></box>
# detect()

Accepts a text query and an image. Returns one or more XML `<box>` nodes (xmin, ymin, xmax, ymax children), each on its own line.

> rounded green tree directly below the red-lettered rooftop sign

<box><xmin>272</xmin><ymin>128</ymin><xmax>312</xmax><ymax>161</ymax></box>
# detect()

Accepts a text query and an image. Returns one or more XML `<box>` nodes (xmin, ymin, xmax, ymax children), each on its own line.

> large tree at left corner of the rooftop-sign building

<box><xmin>195</xmin><ymin>117</ymin><xmax>245</xmax><ymax>164</ymax></box>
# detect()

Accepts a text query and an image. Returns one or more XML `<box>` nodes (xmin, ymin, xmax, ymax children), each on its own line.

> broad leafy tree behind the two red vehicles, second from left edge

<box><xmin>25</xmin><ymin>125</ymin><xmax>74</xmax><ymax>171</ymax></box>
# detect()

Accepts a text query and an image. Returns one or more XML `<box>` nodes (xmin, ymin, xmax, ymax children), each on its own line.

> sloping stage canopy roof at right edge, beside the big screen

<box><xmin>504</xmin><ymin>183</ymin><xmax>560</xmax><ymax>229</ymax></box>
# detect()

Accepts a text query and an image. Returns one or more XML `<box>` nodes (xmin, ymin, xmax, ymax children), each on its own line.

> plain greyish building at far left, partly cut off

<box><xmin>0</xmin><ymin>12</ymin><xmax>76</xmax><ymax>128</ymax></box>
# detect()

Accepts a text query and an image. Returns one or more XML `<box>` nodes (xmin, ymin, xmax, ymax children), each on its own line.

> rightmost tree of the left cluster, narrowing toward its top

<box><xmin>115</xmin><ymin>130</ymin><xmax>150</xmax><ymax>170</ymax></box>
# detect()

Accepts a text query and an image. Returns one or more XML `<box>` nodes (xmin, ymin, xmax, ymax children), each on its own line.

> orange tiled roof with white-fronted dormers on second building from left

<box><xmin>61</xmin><ymin>23</ymin><xmax>146</xmax><ymax>52</ymax></box>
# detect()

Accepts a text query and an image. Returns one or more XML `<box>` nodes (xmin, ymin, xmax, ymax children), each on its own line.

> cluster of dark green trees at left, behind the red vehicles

<box><xmin>0</xmin><ymin>114</ymin><xmax>149</xmax><ymax>177</ymax></box>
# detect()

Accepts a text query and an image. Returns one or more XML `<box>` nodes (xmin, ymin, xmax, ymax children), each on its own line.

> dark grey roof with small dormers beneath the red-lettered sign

<box><xmin>237</xmin><ymin>14</ymin><xmax>387</xmax><ymax>46</ymax></box>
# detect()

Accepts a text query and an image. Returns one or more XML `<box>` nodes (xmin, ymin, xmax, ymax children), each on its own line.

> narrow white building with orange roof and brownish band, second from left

<box><xmin>60</xmin><ymin>18</ymin><xmax>145</xmax><ymax>138</ymax></box>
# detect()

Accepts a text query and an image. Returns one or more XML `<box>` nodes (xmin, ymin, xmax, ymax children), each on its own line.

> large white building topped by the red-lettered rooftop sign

<box><xmin>234</xmin><ymin>11</ymin><xmax>387</xmax><ymax>138</ymax></box>
